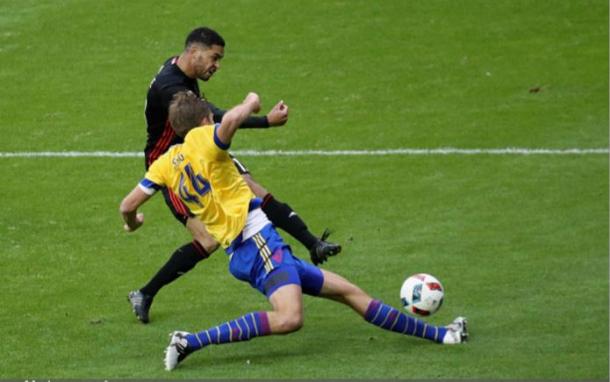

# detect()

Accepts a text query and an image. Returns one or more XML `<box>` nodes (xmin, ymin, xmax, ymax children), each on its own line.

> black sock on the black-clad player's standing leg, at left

<box><xmin>140</xmin><ymin>241</ymin><xmax>209</xmax><ymax>296</ymax></box>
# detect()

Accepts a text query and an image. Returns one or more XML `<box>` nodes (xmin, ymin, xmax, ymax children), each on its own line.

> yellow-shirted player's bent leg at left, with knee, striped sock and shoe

<box><xmin>165</xmin><ymin>284</ymin><xmax>303</xmax><ymax>371</ymax></box>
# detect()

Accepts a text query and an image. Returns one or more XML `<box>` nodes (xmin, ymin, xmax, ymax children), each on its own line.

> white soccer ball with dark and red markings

<box><xmin>400</xmin><ymin>273</ymin><xmax>445</xmax><ymax>316</ymax></box>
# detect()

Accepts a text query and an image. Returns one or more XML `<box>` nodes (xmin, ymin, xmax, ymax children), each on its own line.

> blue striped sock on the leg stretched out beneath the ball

<box><xmin>364</xmin><ymin>300</ymin><xmax>447</xmax><ymax>343</ymax></box>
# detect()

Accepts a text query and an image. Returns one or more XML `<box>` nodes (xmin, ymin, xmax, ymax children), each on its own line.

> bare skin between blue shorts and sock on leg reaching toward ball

<box><xmin>320</xmin><ymin>269</ymin><xmax>372</xmax><ymax>315</ymax></box>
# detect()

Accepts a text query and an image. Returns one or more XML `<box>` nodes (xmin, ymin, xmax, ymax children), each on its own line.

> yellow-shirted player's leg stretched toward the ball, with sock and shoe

<box><xmin>320</xmin><ymin>270</ymin><xmax>468</xmax><ymax>345</ymax></box>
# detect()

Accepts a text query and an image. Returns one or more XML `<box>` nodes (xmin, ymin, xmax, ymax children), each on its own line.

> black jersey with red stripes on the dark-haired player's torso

<box><xmin>144</xmin><ymin>57</ymin><xmax>201</xmax><ymax>169</ymax></box>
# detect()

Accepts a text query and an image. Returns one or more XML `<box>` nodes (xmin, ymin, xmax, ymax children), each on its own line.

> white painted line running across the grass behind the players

<box><xmin>0</xmin><ymin>147</ymin><xmax>609</xmax><ymax>158</ymax></box>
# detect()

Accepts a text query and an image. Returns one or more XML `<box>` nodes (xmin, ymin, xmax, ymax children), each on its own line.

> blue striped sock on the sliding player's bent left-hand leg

<box><xmin>186</xmin><ymin>312</ymin><xmax>271</xmax><ymax>350</ymax></box>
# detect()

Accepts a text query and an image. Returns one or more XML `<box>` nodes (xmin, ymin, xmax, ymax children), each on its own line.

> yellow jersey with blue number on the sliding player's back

<box><xmin>140</xmin><ymin>124</ymin><xmax>254</xmax><ymax>248</ymax></box>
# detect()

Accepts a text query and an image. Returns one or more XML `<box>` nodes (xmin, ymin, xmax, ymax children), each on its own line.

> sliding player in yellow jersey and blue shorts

<box><xmin>120</xmin><ymin>92</ymin><xmax>468</xmax><ymax>370</ymax></box>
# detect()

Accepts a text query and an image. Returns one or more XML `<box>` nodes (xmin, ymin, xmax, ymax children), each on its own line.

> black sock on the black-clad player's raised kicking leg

<box><xmin>261</xmin><ymin>194</ymin><xmax>318</xmax><ymax>249</ymax></box>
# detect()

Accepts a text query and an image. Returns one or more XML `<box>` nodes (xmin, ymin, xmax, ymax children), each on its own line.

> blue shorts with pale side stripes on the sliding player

<box><xmin>227</xmin><ymin>224</ymin><xmax>324</xmax><ymax>297</ymax></box>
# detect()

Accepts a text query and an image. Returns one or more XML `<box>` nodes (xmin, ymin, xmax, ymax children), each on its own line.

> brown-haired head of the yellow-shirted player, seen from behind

<box><xmin>168</xmin><ymin>90</ymin><xmax>210</xmax><ymax>137</ymax></box>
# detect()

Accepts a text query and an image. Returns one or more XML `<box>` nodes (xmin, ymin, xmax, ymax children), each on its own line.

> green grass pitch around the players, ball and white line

<box><xmin>0</xmin><ymin>0</ymin><xmax>609</xmax><ymax>380</ymax></box>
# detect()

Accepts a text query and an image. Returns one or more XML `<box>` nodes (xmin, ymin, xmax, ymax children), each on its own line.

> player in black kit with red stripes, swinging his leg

<box><xmin>128</xmin><ymin>27</ymin><xmax>341</xmax><ymax>323</ymax></box>
